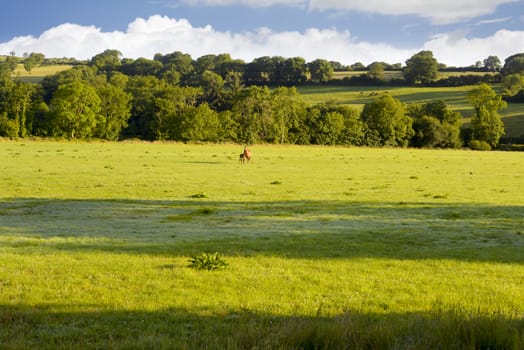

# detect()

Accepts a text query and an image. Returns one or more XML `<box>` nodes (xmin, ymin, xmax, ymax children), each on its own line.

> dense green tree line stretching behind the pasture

<box><xmin>0</xmin><ymin>50</ymin><xmax>524</xmax><ymax>148</ymax></box>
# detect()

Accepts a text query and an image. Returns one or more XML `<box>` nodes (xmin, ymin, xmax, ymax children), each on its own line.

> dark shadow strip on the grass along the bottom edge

<box><xmin>0</xmin><ymin>305</ymin><xmax>524</xmax><ymax>349</ymax></box>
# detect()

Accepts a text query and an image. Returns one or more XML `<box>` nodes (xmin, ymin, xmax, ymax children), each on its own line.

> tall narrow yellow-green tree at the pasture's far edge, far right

<box><xmin>468</xmin><ymin>84</ymin><xmax>507</xmax><ymax>147</ymax></box>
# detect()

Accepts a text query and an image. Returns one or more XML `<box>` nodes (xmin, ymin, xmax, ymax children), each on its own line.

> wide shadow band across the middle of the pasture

<box><xmin>0</xmin><ymin>198</ymin><xmax>524</xmax><ymax>264</ymax></box>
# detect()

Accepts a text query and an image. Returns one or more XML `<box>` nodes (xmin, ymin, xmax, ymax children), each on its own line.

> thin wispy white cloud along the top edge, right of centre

<box><xmin>180</xmin><ymin>0</ymin><xmax>522</xmax><ymax>24</ymax></box>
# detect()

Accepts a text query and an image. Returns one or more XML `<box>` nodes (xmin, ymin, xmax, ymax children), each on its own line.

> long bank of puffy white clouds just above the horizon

<box><xmin>0</xmin><ymin>15</ymin><xmax>524</xmax><ymax>66</ymax></box>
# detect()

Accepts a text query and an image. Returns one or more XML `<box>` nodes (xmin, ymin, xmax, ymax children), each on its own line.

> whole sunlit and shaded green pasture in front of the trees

<box><xmin>0</xmin><ymin>141</ymin><xmax>524</xmax><ymax>349</ymax></box>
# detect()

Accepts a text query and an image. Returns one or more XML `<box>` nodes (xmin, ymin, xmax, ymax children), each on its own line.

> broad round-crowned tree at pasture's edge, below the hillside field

<box><xmin>362</xmin><ymin>95</ymin><xmax>414</xmax><ymax>146</ymax></box>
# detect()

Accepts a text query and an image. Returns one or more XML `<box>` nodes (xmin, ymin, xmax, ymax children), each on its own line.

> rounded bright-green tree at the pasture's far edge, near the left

<box><xmin>50</xmin><ymin>81</ymin><xmax>101</xmax><ymax>139</ymax></box>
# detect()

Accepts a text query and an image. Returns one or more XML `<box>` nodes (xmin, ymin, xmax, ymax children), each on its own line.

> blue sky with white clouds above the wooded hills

<box><xmin>0</xmin><ymin>0</ymin><xmax>524</xmax><ymax>66</ymax></box>
